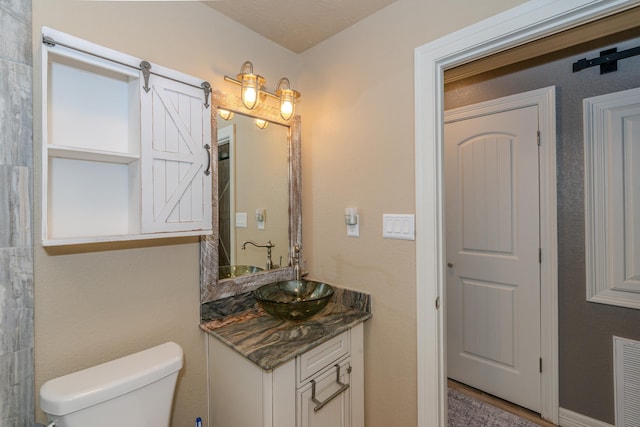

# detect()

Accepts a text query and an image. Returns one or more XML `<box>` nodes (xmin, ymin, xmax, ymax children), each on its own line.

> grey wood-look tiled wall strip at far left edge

<box><xmin>0</xmin><ymin>0</ymin><xmax>34</xmax><ymax>427</ymax></box>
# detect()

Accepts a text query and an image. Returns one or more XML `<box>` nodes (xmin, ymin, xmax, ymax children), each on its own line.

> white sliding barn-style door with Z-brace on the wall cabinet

<box><xmin>140</xmin><ymin>74</ymin><xmax>215</xmax><ymax>233</ymax></box>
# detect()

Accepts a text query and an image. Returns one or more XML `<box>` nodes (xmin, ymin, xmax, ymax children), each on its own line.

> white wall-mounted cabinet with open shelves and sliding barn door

<box><xmin>41</xmin><ymin>27</ymin><xmax>212</xmax><ymax>246</ymax></box>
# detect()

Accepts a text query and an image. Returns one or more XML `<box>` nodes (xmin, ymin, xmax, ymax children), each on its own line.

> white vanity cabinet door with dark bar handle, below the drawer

<box><xmin>296</xmin><ymin>358</ymin><xmax>352</xmax><ymax>427</ymax></box>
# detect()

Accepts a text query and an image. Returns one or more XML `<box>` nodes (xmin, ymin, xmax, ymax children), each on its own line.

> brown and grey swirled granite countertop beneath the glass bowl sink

<box><xmin>200</xmin><ymin>286</ymin><xmax>371</xmax><ymax>371</ymax></box>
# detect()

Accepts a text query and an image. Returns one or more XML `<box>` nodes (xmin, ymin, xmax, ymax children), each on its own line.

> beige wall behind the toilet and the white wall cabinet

<box><xmin>33</xmin><ymin>0</ymin><xmax>298</xmax><ymax>427</ymax></box>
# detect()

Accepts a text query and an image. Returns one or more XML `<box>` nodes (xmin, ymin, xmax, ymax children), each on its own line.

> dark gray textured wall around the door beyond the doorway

<box><xmin>445</xmin><ymin>30</ymin><xmax>640</xmax><ymax>424</ymax></box>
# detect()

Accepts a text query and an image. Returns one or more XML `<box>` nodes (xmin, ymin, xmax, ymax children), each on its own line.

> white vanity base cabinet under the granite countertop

<box><xmin>207</xmin><ymin>323</ymin><xmax>364</xmax><ymax>427</ymax></box>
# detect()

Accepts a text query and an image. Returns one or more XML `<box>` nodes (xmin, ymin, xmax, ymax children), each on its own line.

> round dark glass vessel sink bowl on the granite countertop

<box><xmin>253</xmin><ymin>280</ymin><xmax>333</xmax><ymax>320</ymax></box>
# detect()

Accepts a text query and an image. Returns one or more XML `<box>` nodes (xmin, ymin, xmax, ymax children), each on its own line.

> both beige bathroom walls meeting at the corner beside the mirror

<box><xmin>33</xmin><ymin>0</ymin><xmax>523</xmax><ymax>427</ymax></box>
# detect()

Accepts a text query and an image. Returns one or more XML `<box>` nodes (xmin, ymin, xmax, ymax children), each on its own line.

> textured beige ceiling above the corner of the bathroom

<box><xmin>203</xmin><ymin>0</ymin><xmax>395</xmax><ymax>53</ymax></box>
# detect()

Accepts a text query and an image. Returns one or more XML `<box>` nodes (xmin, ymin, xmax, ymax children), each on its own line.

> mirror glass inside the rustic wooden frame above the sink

<box><xmin>218</xmin><ymin>112</ymin><xmax>289</xmax><ymax>280</ymax></box>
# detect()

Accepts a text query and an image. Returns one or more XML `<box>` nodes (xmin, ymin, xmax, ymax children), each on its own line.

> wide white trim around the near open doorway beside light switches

<box><xmin>415</xmin><ymin>0</ymin><xmax>638</xmax><ymax>427</ymax></box>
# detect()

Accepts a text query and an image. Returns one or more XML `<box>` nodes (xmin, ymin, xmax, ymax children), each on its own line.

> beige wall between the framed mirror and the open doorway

<box><xmin>301</xmin><ymin>0</ymin><xmax>523</xmax><ymax>427</ymax></box>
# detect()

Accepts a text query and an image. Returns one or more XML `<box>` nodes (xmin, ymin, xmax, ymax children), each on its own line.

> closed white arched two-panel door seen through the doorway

<box><xmin>444</xmin><ymin>106</ymin><xmax>541</xmax><ymax>412</ymax></box>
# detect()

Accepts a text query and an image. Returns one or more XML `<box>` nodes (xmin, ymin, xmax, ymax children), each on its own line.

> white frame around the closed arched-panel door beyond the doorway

<box><xmin>441</xmin><ymin>86</ymin><xmax>558</xmax><ymax>414</ymax></box>
